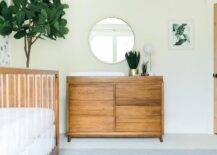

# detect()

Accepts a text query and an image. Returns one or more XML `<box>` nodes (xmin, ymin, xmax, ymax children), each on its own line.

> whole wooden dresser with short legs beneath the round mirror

<box><xmin>66</xmin><ymin>76</ymin><xmax>164</xmax><ymax>142</ymax></box>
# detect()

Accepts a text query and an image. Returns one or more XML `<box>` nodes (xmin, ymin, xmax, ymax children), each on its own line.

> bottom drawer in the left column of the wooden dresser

<box><xmin>69</xmin><ymin>115</ymin><xmax>114</xmax><ymax>133</ymax></box>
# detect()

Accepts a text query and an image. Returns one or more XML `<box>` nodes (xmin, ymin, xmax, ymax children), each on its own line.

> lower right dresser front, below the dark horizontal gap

<box><xmin>116</xmin><ymin>106</ymin><xmax>161</xmax><ymax>132</ymax></box>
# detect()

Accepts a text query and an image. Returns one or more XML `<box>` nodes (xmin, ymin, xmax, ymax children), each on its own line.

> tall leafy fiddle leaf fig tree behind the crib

<box><xmin>0</xmin><ymin>0</ymin><xmax>69</xmax><ymax>68</ymax></box>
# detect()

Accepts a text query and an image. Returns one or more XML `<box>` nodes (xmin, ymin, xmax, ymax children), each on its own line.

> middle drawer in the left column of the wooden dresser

<box><xmin>68</xmin><ymin>100</ymin><xmax>114</xmax><ymax>117</ymax></box>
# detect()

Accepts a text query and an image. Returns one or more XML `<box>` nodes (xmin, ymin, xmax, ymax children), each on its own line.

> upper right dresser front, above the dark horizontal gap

<box><xmin>116</xmin><ymin>83</ymin><xmax>162</xmax><ymax>106</ymax></box>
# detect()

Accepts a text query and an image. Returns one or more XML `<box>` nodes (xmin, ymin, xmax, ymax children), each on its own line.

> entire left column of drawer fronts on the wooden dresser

<box><xmin>68</xmin><ymin>84</ymin><xmax>115</xmax><ymax>133</ymax></box>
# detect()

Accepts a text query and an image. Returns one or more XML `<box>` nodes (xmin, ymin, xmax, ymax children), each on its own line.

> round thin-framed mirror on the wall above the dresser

<box><xmin>89</xmin><ymin>18</ymin><xmax>134</xmax><ymax>63</ymax></box>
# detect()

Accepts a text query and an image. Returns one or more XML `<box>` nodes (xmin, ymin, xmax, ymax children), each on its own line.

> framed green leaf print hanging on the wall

<box><xmin>169</xmin><ymin>21</ymin><xmax>194</xmax><ymax>50</ymax></box>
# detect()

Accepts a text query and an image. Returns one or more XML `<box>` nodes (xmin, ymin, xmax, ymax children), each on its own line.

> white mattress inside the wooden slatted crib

<box><xmin>0</xmin><ymin>108</ymin><xmax>55</xmax><ymax>155</ymax></box>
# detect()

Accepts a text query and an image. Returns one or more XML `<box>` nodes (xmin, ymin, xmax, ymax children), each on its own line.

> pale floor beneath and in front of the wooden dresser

<box><xmin>60</xmin><ymin>134</ymin><xmax>217</xmax><ymax>155</ymax></box>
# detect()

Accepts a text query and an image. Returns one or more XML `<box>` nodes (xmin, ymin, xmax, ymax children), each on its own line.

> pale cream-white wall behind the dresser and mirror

<box><xmin>12</xmin><ymin>0</ymin><xmax>214</xmax><ymax>133</ymax></box>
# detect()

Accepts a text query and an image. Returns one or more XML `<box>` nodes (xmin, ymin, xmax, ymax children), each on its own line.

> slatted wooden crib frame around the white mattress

<box><xmin>0</xmin><ymin>67</ymin><xmax>59</xmax><ymax>155</ymax></box>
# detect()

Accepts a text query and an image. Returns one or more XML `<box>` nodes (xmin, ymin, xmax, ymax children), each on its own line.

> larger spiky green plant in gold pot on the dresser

<box><xmin>125</xmin><ymin>51</ymin><xmax>140</xmax><ymax>76</ymax></box>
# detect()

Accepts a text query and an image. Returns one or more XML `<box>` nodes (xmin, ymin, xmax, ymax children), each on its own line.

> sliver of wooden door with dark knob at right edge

<box><xmin>214</xmin><ymin>4</ymin><xmax>217</xmax><ymax>134</ymax></box>
